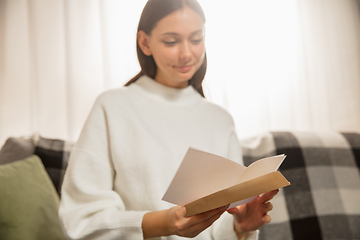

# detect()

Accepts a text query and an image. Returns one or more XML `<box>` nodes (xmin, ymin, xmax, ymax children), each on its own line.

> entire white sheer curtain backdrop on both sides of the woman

<box><xmin>0</xmin><ymin>0</ymin><xmax>360</xmax><ymax>144</ymax></box>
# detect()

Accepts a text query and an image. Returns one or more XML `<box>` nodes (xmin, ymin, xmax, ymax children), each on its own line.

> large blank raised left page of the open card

<box><xmin>162</xmin><ymin>148</ymin><xmax>246</xmax><ymax>206</ymax></box>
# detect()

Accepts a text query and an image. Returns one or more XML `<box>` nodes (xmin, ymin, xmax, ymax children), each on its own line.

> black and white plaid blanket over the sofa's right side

<box><xmin>242</xmin><ymin>132</ymin><xmax>360</xmax><ymax>240</ymax></box>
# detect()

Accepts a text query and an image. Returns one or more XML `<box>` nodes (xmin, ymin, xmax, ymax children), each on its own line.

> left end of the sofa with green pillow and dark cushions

<box><xmin>0</xmin><ymin>134</ymin><xmax>73</xmax><ymax>240</ymax></box>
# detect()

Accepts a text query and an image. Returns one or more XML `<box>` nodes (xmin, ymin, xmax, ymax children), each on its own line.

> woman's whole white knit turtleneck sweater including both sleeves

<box><xmin>59</xmin><ymin>76</ymin><xmax>257</xmax><ymax>240</ymax></box>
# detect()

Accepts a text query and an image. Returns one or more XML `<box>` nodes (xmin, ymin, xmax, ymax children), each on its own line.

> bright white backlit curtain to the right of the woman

<box><xmin>208</xmin><ymin>0</ymin><xmax>360</xmax><ymax>137</ymax></box>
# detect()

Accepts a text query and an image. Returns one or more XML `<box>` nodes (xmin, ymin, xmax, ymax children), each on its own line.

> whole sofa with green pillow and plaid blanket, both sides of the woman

<box><xmin>0</xmin><ymin>132</ymin><xmax>360</xmax><ymax>240</ymax></box>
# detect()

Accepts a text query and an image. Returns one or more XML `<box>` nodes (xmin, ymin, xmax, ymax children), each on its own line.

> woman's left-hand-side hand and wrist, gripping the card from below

<box><xmin>142</xmin><ymin>205</ymin><xmax>229</xmax><ymax>238</ymax></box>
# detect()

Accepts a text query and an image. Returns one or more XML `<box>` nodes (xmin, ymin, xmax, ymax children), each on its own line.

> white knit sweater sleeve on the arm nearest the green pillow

<box><xmin>59</xmin><ymin>96</ymin><xmax>145</xmax><ymax>240</ymax></box>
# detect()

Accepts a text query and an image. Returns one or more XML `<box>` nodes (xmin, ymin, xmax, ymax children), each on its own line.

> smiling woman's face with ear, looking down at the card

<box><xmin>139</xmin><ymin>7</ymin><xmax>205</xmax><ymax>88</ymax></box>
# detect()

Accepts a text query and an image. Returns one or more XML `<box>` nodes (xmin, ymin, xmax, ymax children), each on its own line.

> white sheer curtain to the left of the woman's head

<box><xmin>0</xmin><ymin>0</ymin><xmax>140</xmax><ymax>143</ymax></box>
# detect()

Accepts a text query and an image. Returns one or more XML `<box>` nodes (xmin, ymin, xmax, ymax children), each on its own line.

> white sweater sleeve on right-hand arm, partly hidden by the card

<box><xmin>211</xmin><ymin>130</ymin><xmax>259</xmax><ymax>240</ymax></box>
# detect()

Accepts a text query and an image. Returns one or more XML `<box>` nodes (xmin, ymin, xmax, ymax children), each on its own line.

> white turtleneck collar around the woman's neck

<box><xmin>129</xmin><ymin>75</ymin><xmax>203</xmax><ymax>105</ymax></box>
